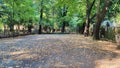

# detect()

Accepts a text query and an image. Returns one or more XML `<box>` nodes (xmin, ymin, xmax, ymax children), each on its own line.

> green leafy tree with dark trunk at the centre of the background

<box><xmin>57</xmin><ymin>0</ymin><xmax>79</xmax><ymax>33</ymax></box>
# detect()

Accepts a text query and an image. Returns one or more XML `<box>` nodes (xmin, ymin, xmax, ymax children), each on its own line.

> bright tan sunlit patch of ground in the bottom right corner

<box><xmin>95</xmin><ymin>41</ymin><xmax>120</xmax><ymax>68</ymax></box>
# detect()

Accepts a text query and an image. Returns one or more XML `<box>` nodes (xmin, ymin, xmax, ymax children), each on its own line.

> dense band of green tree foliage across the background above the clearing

<box><xmin>0</xmin><ymin>0</ymin><xmax>120</xmax><ymax>39</ymax></box>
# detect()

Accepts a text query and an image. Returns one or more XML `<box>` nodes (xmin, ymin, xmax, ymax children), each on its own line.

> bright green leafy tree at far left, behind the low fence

<box><xmin>3</xmin><ymin>0</ymin><xmax>36</xmax><ymax>32</ymax></box>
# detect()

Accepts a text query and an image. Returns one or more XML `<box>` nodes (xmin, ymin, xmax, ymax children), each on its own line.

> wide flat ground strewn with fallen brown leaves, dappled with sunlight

<box><xmin>0</xmin><ymin>34</ymin><xmax>120</xmax><ymax>68</ymax></box>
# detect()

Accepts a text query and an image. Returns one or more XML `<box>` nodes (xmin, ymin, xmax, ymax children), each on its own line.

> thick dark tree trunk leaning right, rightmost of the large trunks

<box><xmin>93</xmin><ymin>0</ymin><xmax>111</xmax><ymax>40</ymax></box>
